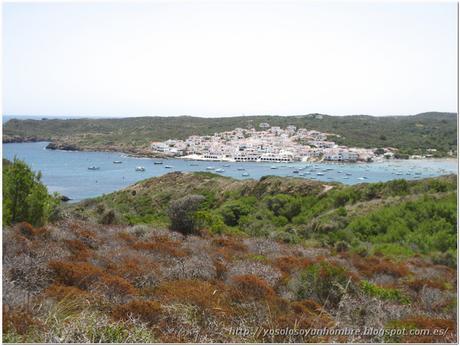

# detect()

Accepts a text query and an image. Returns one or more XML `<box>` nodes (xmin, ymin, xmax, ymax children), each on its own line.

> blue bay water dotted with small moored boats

<box><xmin>3</xmin><ymin>142</ymin><xmax>457</xmax><ymax>200</ymax></box>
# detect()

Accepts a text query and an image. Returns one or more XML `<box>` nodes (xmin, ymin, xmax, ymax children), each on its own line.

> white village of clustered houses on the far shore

<box><xmin>151</xmin><ymin>123</ymin><xmax>384</xmax><ymax>162</ymax></box>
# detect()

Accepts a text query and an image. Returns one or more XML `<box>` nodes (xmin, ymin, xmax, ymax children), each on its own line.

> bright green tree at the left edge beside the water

<box><xmin>3</xmin><ymin>157</ymin><xmax>56</xmax><ymax>226</ymax></box>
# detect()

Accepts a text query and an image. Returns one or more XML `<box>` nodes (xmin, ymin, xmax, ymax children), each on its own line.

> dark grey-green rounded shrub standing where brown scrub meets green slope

<box><xmin>168</xmin><ymin>195</ymin><xmax>205</xmax><ymax>235</ymax></box>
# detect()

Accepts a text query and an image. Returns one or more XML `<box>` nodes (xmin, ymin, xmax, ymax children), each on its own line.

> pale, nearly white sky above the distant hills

<box><xmin>2</xmin><ymin>0</ymin><xmax>457</xmax><ymax>117</ymax></box>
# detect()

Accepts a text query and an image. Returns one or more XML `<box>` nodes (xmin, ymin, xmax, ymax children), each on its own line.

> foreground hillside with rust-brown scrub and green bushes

<box><xmin>3</xmin><ymin>173</ymin><xmax>457</xmax><ymax>343</ymax></box>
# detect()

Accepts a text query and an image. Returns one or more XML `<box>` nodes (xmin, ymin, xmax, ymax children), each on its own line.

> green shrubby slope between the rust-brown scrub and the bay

<box><xmin>72</xmin><ymin>173</ymin><xmax>457</xmax><ymax>266</ymax></box>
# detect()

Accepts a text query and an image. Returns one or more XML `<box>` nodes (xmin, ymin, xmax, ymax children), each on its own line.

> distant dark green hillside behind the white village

<box><xmin>3</xmin><ymin>112</ymin><xmax>457</xmax><ymax>156</ymax></box>
